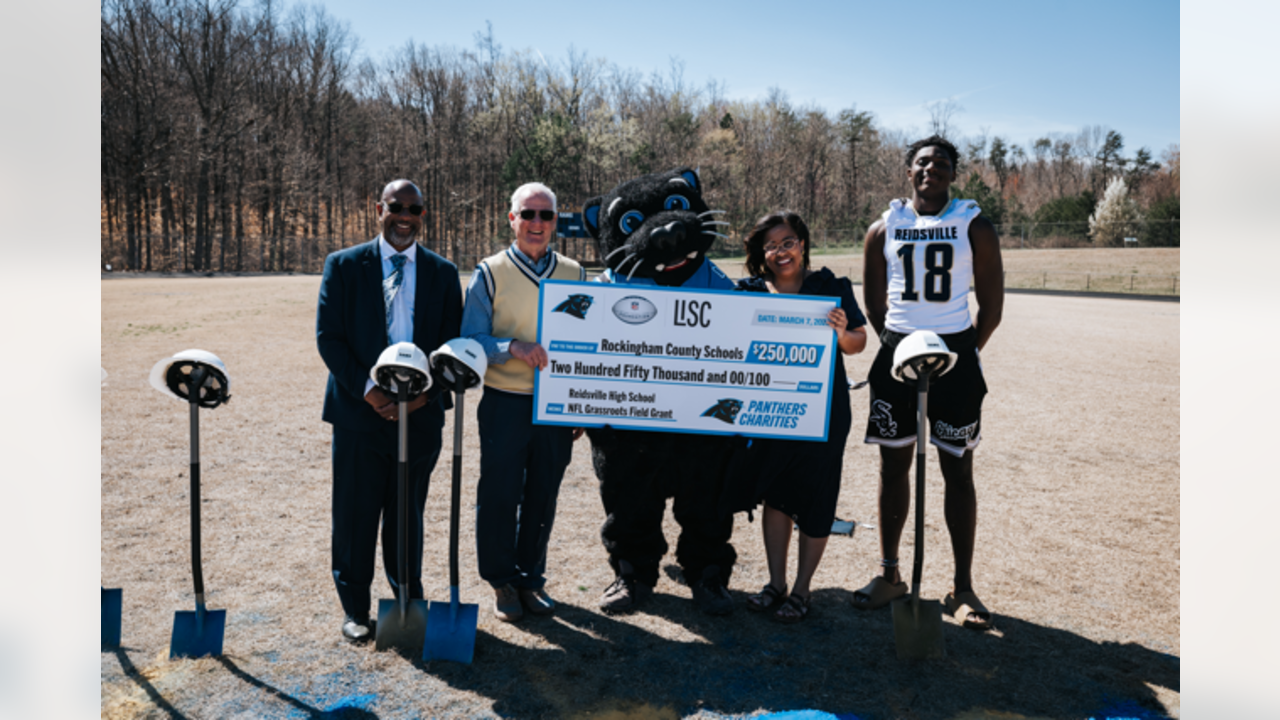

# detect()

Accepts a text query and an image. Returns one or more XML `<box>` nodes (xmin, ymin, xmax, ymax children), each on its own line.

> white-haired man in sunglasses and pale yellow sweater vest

<box><xmin>462</xmin><ymin>183</ymin><xmax>586</xmax><ymax>623</ymax></box>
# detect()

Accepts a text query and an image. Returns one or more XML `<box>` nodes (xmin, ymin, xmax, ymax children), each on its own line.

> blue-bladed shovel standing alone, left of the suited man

<box><xmin>169</xmin><ymin>365</ymin><xmax>227</xmax><ymax>659</ymax></box>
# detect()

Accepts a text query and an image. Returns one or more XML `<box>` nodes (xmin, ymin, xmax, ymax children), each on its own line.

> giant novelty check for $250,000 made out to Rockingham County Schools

<box><xmin>534</xmin><ymin>281</ymin><xmax>840</xmax><ymax>441</ymax></box>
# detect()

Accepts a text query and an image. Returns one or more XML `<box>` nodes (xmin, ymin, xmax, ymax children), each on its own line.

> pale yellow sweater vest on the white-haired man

<box><xmin>476</xmin><ymin>247</ymin><xmax>586</xmax><ymax>395</ymax></box>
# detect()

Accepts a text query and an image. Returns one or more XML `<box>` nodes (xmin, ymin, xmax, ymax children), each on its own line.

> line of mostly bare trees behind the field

<box><xmin>100</xmin><ymin>0</ymin><xmax>1180</xmax><ymax>272</ymax></box>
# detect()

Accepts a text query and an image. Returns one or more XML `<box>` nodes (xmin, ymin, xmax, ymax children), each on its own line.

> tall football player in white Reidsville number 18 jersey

<box><xmin>854</xmin><ymin>136</ymin><xmax>1005</xmax><ymax>630</ymax></box>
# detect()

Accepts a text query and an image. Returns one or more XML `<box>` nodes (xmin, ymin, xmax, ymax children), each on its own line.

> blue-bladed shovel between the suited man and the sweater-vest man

<box><xmin>422</xmin><ymin>389</ymin><xmax>480</xmax><ymax>665</ymax></box>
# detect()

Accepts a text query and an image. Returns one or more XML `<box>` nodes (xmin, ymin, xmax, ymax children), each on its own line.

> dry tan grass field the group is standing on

<box><xmin>101</xmin><ymin>266</ymin><xmax>1181</xmax><ymax>720</ymax></box>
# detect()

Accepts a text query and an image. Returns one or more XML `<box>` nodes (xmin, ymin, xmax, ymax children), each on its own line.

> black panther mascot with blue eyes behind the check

<box><xmin>582</xmin><ymin>168</ymin><xmax>741</xmax><ymax>615</ymax></box>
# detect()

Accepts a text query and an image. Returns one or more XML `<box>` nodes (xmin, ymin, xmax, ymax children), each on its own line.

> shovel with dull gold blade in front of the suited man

<box><xmin>374</xmin><ymin>375</ymin><xmax>426</xmax><ymax>656</ymax></box>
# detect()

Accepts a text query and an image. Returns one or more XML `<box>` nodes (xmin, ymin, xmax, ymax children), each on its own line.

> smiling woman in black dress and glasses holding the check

<box><xmin>737</xmin><ymin>210</ymin><xmax>867</xmax><ymax>623</ymax></box>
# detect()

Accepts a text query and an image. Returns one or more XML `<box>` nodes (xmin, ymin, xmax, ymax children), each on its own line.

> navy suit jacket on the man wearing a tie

<box><xmin>316</xmin><ymin>238</ymin><xmax>462</xmax><ymax>437</ymax></box>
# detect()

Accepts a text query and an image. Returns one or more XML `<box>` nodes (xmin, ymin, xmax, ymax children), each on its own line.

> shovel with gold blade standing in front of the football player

<box><xmin>893</xmin><ymin>363</ymin><xmax>947</xmax><ymax>660</ymax></box>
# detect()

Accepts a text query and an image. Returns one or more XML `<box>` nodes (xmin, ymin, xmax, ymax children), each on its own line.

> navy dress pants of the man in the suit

<box><xmin>333</xmin><ymin>423</ymin><xmax>440</xmax><ymax>620</ymax></box>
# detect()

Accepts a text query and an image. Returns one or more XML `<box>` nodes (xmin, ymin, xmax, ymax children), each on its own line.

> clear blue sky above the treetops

<box><xmin>309</xmin><ymin>0</ymin><xmax>1180</xmax><ymax>158</ymax></box>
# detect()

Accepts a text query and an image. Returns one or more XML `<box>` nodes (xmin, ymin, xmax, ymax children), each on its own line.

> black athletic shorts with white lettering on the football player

<box><xmin>867</xmin><ymin>328</ymin><xmax>987</xmax><ymax>457</ymax></box>
